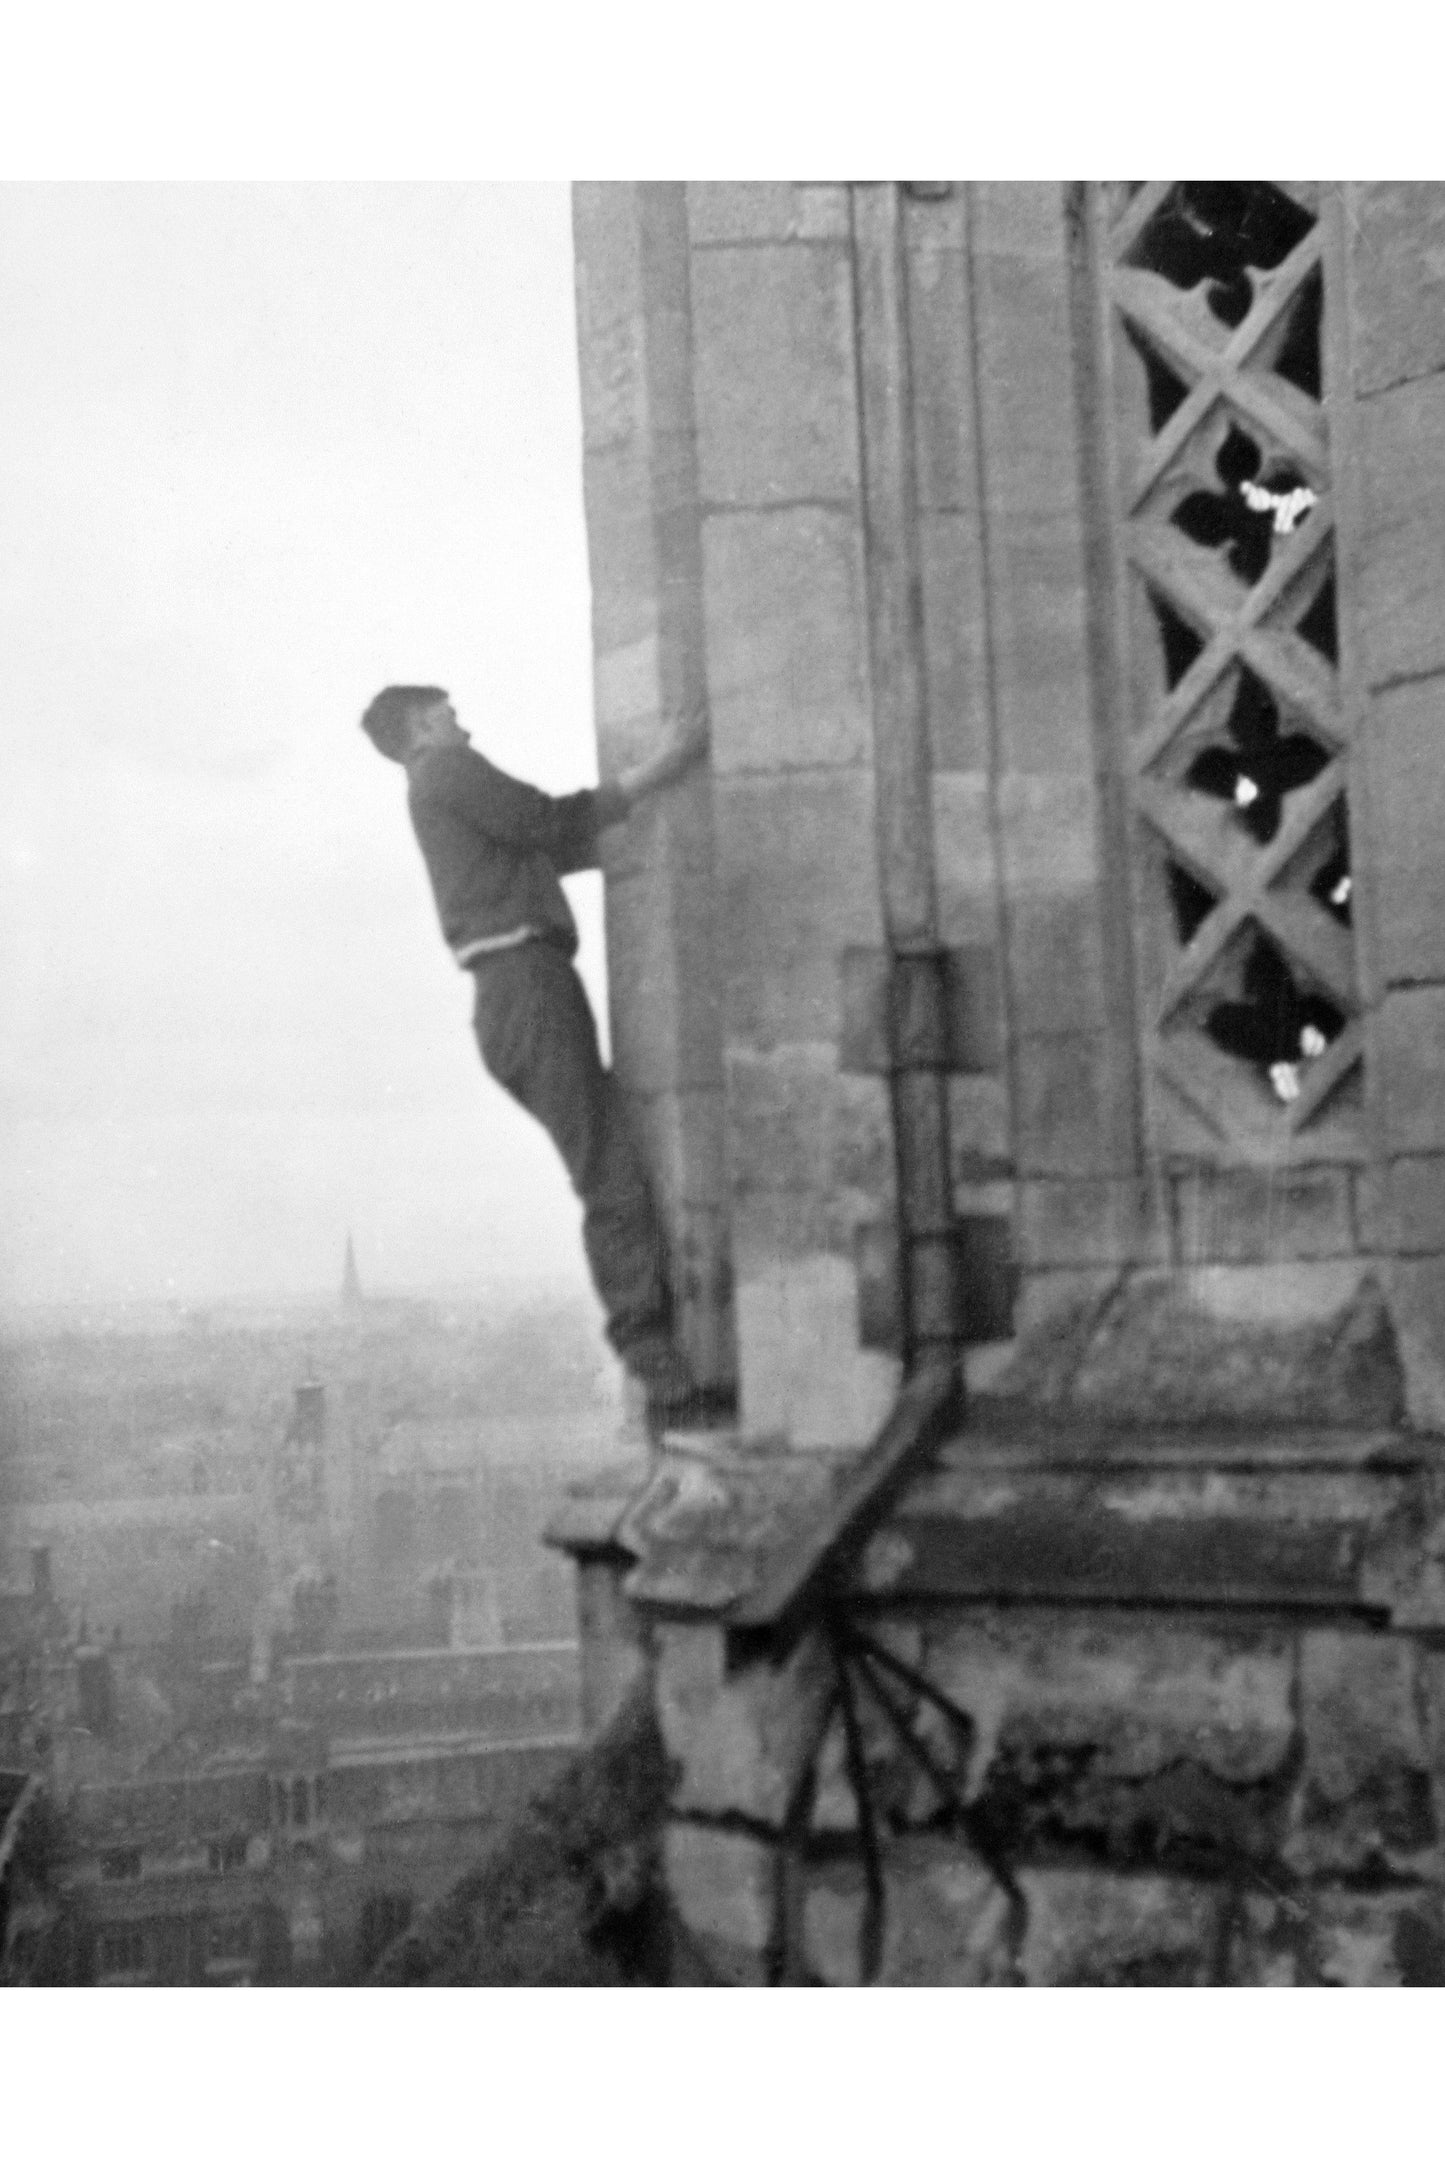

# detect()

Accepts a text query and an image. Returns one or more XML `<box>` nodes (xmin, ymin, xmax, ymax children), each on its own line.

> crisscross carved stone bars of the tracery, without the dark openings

<box><xmin>1107</xmin><ymin>182</ymin><xmax>1363</xmax><ymax>1143</ymax></box>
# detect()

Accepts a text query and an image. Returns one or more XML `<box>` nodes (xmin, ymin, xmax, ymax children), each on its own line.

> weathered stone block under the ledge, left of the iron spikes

<box><xmin>656</xmin><ymin>1622</ymin><xmax>832</xmax><ymax>1828</ymax></box>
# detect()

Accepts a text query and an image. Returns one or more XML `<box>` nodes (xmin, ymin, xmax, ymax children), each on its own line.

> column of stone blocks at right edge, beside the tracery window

<box><xmin>1341</xmin><ymin>182</ymin><xmax>1445</xmax><ymax>1429</ymax></box>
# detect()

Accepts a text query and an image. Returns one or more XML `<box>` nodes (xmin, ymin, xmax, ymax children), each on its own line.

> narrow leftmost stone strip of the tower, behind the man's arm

<box><xmin>574</xmin><ymin>184</ymin><xmax>737</xmax><ymax>1385</ymax></box>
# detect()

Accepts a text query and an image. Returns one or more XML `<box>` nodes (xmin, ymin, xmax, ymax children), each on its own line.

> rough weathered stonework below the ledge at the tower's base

<box><xmin>659</xmin><ymin>1569</ymin><xmax>1445</xmax><ymax>1986</ymax></box>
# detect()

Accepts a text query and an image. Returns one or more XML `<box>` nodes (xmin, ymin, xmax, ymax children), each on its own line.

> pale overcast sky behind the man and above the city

<box><xmin>0</xmin><ymin>182</ymin><xmax>600</xmax><ymax>1301</ymax></box>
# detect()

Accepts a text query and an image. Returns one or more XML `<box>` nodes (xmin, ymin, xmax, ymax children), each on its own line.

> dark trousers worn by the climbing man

<box><xmin>470</xmin><ymin>941</ymin><xmax>676</xmax><ymax>1381</ymax></box>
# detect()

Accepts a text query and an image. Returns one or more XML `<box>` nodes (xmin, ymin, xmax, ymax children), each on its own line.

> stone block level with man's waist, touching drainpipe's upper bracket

<box><xmin>715</xmin><ymin>770</ymin><xmax>882</xmax><ymax>1049</ymax></box>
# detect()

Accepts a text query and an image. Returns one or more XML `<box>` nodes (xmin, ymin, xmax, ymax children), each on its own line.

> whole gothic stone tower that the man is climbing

<box><xmin>545</xmin><ymin>180</ymin><xmax>1445</xmax><ymax>1984</ymax></box>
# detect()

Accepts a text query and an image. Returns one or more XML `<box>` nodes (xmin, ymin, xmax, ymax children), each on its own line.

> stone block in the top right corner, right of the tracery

<box><xmin>1350</xmin><ymin>180</ymin><xmax>1445</xmax><ymax>392</ymax></box>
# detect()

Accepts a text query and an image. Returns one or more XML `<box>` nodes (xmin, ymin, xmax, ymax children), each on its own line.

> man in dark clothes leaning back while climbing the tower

<box><xmin>362</xmin><ymin>685</ymin><xmax>721</xmax><ymax>1433</ymax></box>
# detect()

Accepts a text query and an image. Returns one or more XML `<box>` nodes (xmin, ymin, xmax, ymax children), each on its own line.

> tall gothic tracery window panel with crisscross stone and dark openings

<box><xmin>1094</xmin><ymin>182</ymin><xmax>1363</xmax><ymax>1158</ymax></box>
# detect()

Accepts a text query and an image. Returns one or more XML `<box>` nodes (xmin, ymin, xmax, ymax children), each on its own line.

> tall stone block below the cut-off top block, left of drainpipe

<box><xmin>693</xmin><ymin>247</ymin><xmax>858</xmax><ymax>505</ymax></box>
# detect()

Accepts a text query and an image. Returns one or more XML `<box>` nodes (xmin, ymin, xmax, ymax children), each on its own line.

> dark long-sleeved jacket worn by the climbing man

<box><xmin>407</xmin><ymin>746</ymin><xmax>626</xmax><ymax>956</ymax></box>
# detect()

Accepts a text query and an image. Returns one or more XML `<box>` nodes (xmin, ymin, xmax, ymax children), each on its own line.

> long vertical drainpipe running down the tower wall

<box><xmin>849</xmin><ymin>182</ymin><xmax>964</xmax><ymax>1392</ymax></box>
